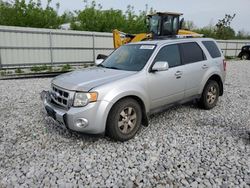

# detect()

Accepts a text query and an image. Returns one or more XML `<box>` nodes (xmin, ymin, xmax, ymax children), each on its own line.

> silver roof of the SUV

<box><xmin>129</xmin><ymin>38</ymin><xmax>214</xmax><ymax>46</ymax></box>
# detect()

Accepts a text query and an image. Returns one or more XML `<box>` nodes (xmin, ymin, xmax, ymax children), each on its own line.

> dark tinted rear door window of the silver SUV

<box><xmin>181</xmin><ymin>42</ymin><xmax>206</xmax><ymax>64</ymax></box>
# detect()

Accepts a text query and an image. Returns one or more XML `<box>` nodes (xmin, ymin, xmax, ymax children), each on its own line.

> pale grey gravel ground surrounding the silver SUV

<box><xmin>0</xmin><ymin>61</ymin><xmax>250</xmax><ymax>187</ymax></box>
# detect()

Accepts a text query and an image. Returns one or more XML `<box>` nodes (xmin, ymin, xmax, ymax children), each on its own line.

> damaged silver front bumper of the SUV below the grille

<box><xmin>41</xmin><ymin>91</ymin><xmax>112</xmax><ymax>134</ymax></box>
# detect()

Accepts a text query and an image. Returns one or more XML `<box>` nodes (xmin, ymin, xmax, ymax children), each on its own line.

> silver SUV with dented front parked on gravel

<box><xmin>42</xmin><ymin>38</ymin><xmax>226</xmax><ymax>141</ymax></box>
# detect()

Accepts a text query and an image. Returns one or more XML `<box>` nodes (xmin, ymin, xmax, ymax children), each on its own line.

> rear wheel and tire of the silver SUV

<box><xmin>199</xmin><ymin>80</ymin><xmax>220</xmax><ymax>110</ymax></box>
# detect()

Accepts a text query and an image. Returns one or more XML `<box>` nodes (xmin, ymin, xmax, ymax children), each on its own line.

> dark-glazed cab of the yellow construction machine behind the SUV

<box><xmin>147</xmin><ymin>12</ymin><xmax>183</xmax><ymax>38</ymax></box>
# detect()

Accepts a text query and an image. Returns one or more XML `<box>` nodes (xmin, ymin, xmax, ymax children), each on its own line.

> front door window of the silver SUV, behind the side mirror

<box><xmin>154</xmin><ymin>44</ymin><xmax>181</xmax><ymax>67</ymax></box>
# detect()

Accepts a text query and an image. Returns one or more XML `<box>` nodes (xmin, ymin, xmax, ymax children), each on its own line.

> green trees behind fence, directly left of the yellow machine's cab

<box><xmin>71</xmin><ymin>1</ymin><xmax>150</xmax><ymax>33</ymax></box>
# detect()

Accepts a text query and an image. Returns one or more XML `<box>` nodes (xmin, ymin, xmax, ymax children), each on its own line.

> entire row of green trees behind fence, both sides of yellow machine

<box><xmin>0</xmin><ymin>0</ymin><xmax>250</xmax><ymax>39</ymax></box>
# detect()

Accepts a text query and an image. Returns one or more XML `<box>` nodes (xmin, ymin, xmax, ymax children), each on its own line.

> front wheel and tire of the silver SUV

<box><xmin>106</xmin><ymin>98</ymin><xmax>142</xmax><ymax>141</ymax></box>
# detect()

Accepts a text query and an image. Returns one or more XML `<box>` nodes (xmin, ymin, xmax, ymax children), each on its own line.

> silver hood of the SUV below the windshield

<box><xmin>52</xmin><ymin>67</ymin><xmax>136</xmax><ymax>91</ymax></box>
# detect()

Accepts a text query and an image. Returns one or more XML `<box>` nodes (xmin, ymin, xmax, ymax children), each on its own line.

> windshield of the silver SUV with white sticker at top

<box><xmin>100</xmin><ymin>44</ymin><xmax>155</xmax><ymax>71</ymax></box>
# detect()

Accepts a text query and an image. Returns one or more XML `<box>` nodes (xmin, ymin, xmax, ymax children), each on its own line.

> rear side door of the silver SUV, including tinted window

<box><xmin>180</xmin><ymin>42</ymin><xmax>210</xmax><ymax>98</ymax></box>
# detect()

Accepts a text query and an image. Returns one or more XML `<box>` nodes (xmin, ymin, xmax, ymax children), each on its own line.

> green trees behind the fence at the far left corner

<box><xmin>0</xmin><ymin>0</ymin><xmax>64</xmax><ymax>28</ymax></box>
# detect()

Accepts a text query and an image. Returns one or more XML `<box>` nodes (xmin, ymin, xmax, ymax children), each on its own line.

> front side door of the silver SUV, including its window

<box><xmin>147</xmin><ymin>44</ymin><xmax>185</xmax><ymax>108</ymax></box>
